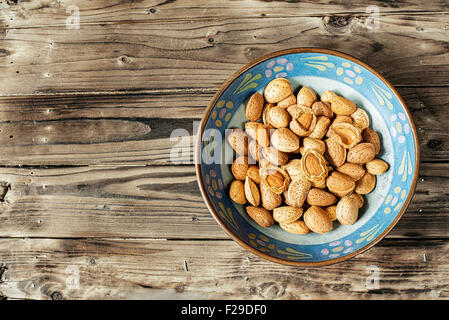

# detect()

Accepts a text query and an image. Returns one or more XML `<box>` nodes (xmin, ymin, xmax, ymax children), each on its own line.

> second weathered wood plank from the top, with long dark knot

<box><xmin>0</xmin><ymin>88</ymin><xmax>449</xmax><ymax>166</ymax></box>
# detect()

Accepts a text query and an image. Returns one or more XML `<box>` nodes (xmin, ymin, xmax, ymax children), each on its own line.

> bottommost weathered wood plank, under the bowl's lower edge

<box><xmin>0</xmin><ymin>239</ymin><xmax>449</xmax><ymax>299</ymax></box>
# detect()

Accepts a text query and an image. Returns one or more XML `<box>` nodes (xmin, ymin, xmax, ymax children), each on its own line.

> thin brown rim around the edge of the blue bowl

<box><xmin>194</xmin><ymin>47</ymin><xmax>420</xmax><ymax>267</ymax></box>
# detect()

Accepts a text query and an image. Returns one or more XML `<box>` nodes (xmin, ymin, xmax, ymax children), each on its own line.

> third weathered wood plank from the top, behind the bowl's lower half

<box><xmin>0</xmin><ymin>164</ymin><xmax>449</xmax><ymax>239</ymax></box>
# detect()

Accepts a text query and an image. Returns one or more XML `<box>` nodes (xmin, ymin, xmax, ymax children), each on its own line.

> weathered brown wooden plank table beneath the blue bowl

<box><xmin>0</xmin><ymin>0</ymin><xmax>449</xmax><ymax>299</ymax></box>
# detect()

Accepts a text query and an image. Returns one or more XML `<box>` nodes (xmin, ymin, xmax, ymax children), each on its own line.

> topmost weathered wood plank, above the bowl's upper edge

<box><xmin>0</xmin><ymin>0</ymin><xmax>449</xmax><ymax>95</ymax></box>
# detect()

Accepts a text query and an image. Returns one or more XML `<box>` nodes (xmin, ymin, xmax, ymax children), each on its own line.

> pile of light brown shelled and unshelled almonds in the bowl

<box><xmin>227</xmin><ymin>78</ymin><xmax>388</xmax><ymax>234</ymax></box>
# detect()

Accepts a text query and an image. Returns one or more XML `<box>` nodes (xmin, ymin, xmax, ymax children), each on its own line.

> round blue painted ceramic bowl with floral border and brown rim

<box><xmin>195</xmin><ymin>48</ymin><xmax>419</xmax><ymax>266</ymax></box>
